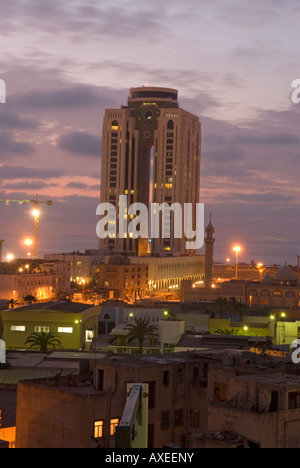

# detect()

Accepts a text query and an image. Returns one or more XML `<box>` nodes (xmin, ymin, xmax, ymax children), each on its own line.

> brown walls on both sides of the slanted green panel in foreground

<box><xmin>16</xmin><ymin>354</ymin><xmax>211</xmax><ymax>448</ymax></box>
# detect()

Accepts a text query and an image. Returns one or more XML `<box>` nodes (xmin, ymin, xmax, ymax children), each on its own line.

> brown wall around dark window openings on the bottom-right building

<box><xmin>208</xmin><ymin>368</ymin><xmax>300</xmax><ymax>448</ymax></box>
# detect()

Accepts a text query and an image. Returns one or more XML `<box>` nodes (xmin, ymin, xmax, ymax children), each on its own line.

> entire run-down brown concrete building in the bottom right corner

<box><xmin>191</xmin><ymin>358</ymin><xmax>300</xmax><ymax>448</ymax></box>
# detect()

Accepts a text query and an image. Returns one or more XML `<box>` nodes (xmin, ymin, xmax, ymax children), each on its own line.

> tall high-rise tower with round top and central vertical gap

<box><xmin>100</xmin><ymin>87</ymin><xmax>201</xmax><ymax>256</ymax></box>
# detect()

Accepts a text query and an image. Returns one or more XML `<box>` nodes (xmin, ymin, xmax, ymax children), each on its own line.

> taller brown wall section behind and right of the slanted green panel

<box><xmin>95</xmin><ymin>363</ymin><xmax>207</xmax><ymax>448</ymax></box>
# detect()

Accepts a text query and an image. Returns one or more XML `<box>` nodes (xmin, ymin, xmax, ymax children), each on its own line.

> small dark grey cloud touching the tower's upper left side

<box><xmin>58</xmin><ymin>132</ymin><xmax>101</xmax><ymax>158</ymax></box>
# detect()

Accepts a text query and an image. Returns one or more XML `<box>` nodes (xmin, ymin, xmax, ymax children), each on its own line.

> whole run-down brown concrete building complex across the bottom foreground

<box><xmin>16</xmin><ymin>345</ymin><xmax>300</xmax><ymax>448</ymax></box>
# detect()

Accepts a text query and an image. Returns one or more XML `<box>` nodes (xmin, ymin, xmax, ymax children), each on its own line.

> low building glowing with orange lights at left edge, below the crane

<box><xmin>0</xmin><ymin>259</ymin><xmax>70</xmax><ymax>303</ymax></box>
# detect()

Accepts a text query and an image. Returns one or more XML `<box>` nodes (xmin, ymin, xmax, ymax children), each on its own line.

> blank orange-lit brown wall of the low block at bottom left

<box><xmin>16</xmin><ymin>383</ymin><xmax>109</xmax><ymax>448</ymax></box>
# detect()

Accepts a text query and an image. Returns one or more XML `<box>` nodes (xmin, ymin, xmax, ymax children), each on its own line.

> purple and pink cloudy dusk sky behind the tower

<box><xmin>0</xmin><ymin>0</ymin><xmax>300</xmax><ymax>265</ymax></box>
